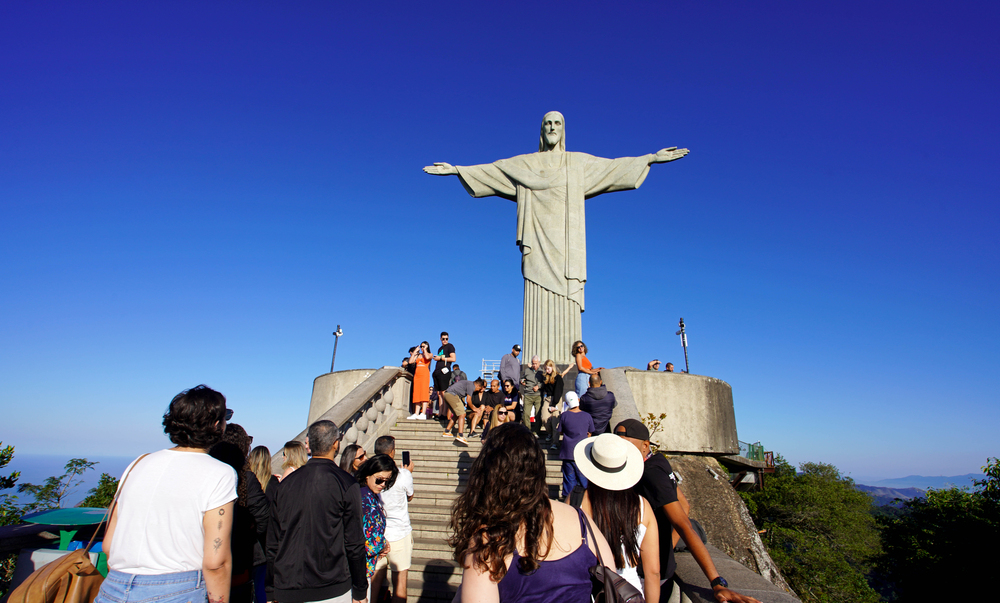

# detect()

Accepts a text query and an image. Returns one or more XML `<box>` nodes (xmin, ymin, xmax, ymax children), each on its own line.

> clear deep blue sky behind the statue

<box><xmin>0</xmin><ymin>1</ymin><xmax>1000</xmax><ymax>477</ymax></box>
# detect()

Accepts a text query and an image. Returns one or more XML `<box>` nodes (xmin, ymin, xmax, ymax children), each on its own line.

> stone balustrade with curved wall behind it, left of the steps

<box><xmin>271</xmin><ymin>366</ymin><xmax>412</xmax><ymax>473</ymax></box>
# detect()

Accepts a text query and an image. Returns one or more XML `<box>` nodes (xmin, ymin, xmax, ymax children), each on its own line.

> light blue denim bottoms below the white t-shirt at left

<box><xmin>94</xmin><ymin>570</ymin><xmax>208</xmax><ymax>603</ymax></box>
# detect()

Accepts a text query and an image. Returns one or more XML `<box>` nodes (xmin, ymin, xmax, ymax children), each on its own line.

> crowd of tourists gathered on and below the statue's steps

<box><xmin>97</xmin><ymin>358</ymin><xmax>755</xmax><ymax>603</ymax></box>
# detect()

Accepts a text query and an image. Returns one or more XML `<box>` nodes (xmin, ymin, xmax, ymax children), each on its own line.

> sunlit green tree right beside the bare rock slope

<box><xmin>742</xmin><ymin>454</ymin><xmax>881</xmax><ymax>603</ymax></box>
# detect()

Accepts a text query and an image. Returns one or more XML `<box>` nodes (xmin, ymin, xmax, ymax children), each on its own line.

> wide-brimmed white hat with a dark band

<box><xmin>573</xmin><ymin>433</ymin><xmax>643</xmax><ymax>490</ymax></box>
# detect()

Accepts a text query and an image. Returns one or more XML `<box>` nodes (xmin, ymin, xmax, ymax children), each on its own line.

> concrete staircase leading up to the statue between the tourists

<box><xmin>390</xmin><ymin>419</ymin><xmax>562</xmax><ymax>602</ymax></box>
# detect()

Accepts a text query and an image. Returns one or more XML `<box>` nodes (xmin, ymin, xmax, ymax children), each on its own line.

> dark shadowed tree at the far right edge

<box><xmin>878</xmin><ymin>458</ymin><xmax>1000</xmax><ymax>602</ymax></box>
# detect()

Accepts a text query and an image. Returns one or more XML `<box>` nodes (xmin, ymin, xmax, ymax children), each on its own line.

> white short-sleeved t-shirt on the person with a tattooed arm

<box><xmin>108</xmin><ymin>450</ymin><xmax>236</xmax><ymax>575</ymax></box>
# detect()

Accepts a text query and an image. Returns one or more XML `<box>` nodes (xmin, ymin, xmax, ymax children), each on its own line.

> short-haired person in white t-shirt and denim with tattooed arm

<box><xmin>95</xmin><ymin>385</ymin><xmax>236</xmax><ymax>603</ymax></box>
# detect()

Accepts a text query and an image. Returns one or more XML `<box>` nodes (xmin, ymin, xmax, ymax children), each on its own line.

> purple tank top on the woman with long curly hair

<box><xmin>497</xmin><ymin>509</ymin><xmax>597</xmax><ymax>603</ymax></box>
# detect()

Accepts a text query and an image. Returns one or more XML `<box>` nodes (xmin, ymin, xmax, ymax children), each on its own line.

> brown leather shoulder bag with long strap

<box><xmin>7</xmin><ymin>454</ymin><xmax>146</xmax><ymax>603</ymax></box>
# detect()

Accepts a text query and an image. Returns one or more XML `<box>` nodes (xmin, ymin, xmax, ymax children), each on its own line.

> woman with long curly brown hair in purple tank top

<box><xmin>449</xmin><ymin>423</ymin><xmax>614</xmax><ymax>603</ymax></box>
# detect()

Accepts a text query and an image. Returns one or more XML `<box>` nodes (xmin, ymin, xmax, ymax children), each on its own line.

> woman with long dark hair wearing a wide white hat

<box><xmin>573</xmin><ymin>433</ymin><xmax>660</xmax><ymax>603</ymax></box>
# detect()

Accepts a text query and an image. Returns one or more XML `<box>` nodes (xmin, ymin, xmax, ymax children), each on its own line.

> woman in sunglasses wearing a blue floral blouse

<box><xmin>357</xmin><ymin>454</ymin><xmax>399</xmax><ymax>601</ymax></box>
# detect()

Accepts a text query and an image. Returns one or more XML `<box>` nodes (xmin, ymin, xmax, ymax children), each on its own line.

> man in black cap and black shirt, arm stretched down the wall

<box><xmin>615</xmin><ymin>419</ymin><xmax>759</xmax><ymax>603</ymax></box>
